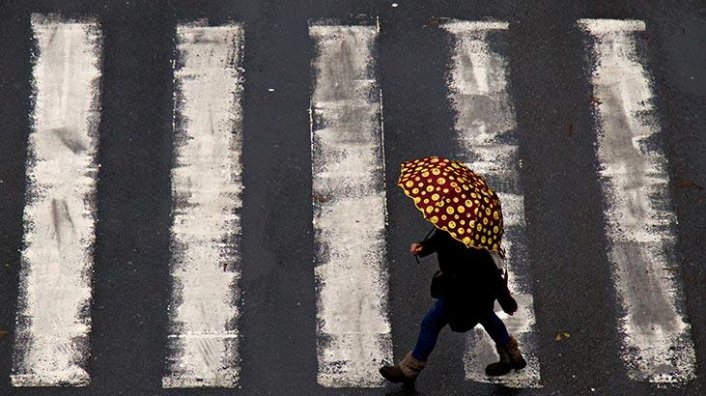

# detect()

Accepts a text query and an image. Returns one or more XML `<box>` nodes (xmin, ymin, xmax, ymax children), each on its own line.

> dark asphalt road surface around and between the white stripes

<box><xmin>0</xmin><ymin>0</ymin><xmax>706</xmax><ymax>395</ymax></box>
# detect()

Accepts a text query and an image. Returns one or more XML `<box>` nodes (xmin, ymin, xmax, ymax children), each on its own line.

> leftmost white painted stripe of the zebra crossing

<box><xmin>11</xmin><ymin>14</ymin><xmax>102</xmax><ymax>386</ymax></box>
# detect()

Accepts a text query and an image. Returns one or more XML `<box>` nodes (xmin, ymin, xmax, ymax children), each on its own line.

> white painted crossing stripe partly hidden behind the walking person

<box><xmin>442</xmin><ymin>21</ymin><xmax>540</xmax><ymax>387</ymax></box>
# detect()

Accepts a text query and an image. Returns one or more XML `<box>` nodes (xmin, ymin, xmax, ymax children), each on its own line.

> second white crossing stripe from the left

<box><xmin>162</xmin><ymin>24</ymin><xmax>244</xmax><ymax>388</ymax></box>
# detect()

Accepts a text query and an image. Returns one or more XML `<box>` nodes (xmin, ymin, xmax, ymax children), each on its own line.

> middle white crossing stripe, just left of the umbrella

<box><xmin>309</xmin><ymin>21</ymin><xmax>392</xmax><ymax>387</ymax></box>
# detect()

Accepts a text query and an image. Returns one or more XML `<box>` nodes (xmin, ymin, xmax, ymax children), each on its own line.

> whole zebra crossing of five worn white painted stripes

<box><xmin>4</xmin><ymin>14</ymin><xmax>696</xmax><ymax>388</ymax></box>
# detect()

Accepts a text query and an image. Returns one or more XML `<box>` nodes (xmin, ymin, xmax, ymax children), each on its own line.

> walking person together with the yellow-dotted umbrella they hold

<box><xmin>380</xmin><ymin>156</ymin><xmax>527</xmax><ymax>385</ymax></box>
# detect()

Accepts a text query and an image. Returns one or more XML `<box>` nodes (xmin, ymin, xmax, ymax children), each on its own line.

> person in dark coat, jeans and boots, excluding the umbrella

<box><xmin>380</xmin><ymin>229</ymin><xmax>527</xmax><ymax>384</ymax></box>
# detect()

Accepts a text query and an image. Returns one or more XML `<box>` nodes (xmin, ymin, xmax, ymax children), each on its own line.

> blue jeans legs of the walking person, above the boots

<box><xmin>412</xmin><ymin>298</ymin><xmax>510</xmax><ymax>361</ymax></box>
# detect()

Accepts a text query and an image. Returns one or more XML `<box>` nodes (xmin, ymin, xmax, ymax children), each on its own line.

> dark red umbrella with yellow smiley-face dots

<box><xmin>397</xmin><ymin>157</ymin><xmax>503</xmax><ymax>253</ymax></box>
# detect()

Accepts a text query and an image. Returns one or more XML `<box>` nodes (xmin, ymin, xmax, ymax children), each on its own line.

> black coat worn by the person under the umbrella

<box><xmin>420</xmin><ymin>230</ymin><xmax>505</xmax><ymax>332</ymax></box>
